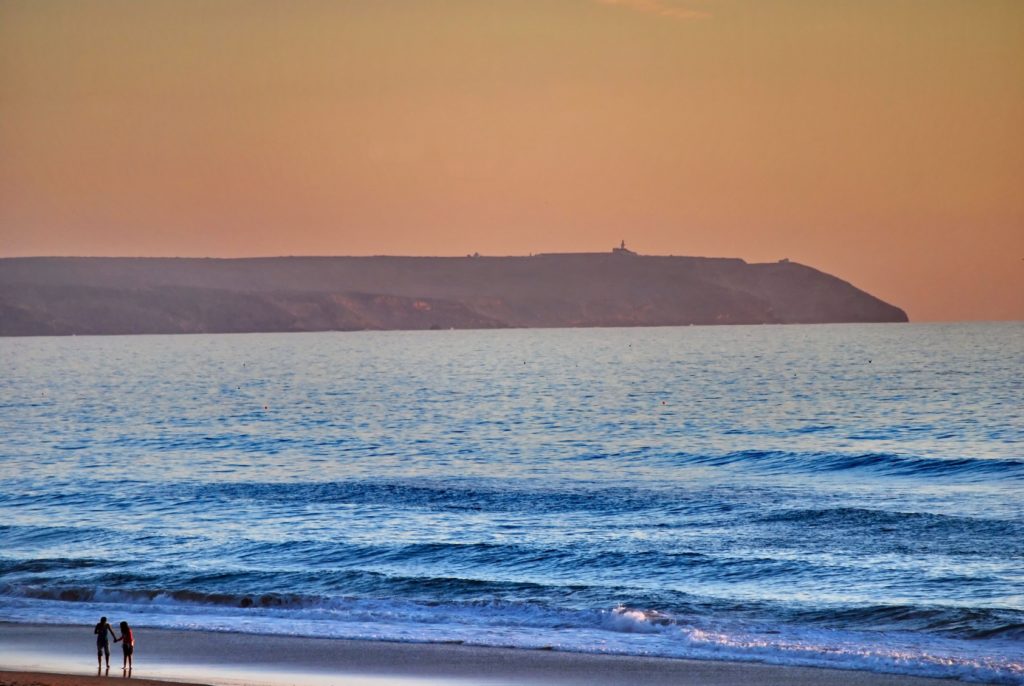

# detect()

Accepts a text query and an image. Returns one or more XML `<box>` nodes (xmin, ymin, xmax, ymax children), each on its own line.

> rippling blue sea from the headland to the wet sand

<box><xmin>0</xmin><ymin>324</ymin><xmax>1024</xmax><ymax>684</ymax></box>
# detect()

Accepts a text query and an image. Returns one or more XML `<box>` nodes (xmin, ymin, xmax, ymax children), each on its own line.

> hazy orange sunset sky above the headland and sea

<box><xmin>0</xmin><ymin>0</ymin><xmax>1024</xmax><ymax>320</ymax></box>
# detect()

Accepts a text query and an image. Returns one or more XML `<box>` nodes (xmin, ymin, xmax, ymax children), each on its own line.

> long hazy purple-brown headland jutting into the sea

<box><xmin>0</xmin><ymin>253</ymin><xmax>907</xmax><ymax>336</ymax></box>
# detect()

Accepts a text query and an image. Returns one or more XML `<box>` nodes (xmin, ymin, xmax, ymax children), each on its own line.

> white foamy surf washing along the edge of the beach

<box><xmin>0</xmin><ymin>592</ymin><xmax>1024</xmax><ymax>686</ymax></box>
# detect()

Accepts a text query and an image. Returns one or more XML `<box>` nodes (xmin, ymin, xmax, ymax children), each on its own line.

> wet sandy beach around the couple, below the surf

<box><xmin>0</xmin><ymin>624</ymin><xmax>983</xmax><ymax>686</ymax></box>
